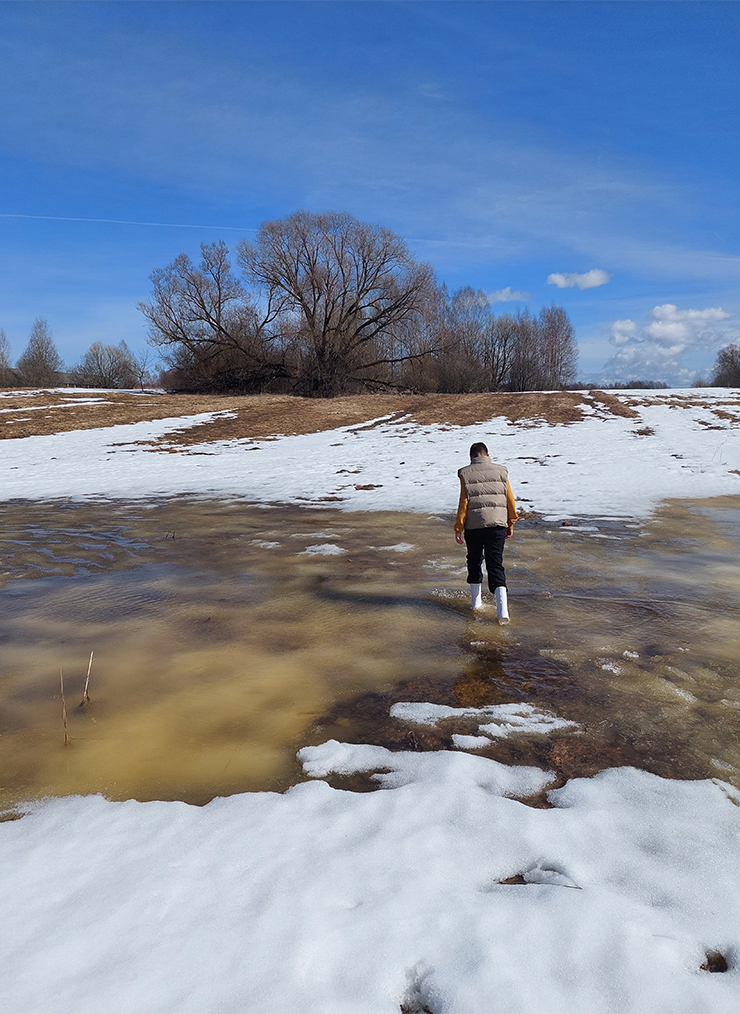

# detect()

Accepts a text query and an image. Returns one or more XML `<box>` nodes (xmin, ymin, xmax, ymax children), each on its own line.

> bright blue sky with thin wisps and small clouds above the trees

<box><xmin>0</xmin><ymin>0</ymin><xmax>740</xmax><ymax>383</ymax></box>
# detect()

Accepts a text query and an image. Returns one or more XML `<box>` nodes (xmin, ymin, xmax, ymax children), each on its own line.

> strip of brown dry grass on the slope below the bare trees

<box><xmin>0</xmin><ymin>390</ymin><xmax>693</xmax><ymax>448</ymax></box>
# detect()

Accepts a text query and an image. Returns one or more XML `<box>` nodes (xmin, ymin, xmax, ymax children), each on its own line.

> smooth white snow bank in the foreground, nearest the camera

<box><xmin>0</xmin><ymin>742</ymin><xmax>740</xmax><ymax>1014</ymax></box>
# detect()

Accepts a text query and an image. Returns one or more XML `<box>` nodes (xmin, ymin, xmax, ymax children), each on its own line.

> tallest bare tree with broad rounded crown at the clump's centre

<box><xmin>239</xmin><ymin>211</ymin><xmax>434</xmax><ymax>397</ymax></box>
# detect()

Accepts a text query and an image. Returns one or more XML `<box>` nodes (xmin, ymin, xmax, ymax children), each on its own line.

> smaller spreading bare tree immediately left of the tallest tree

<box><xmin>139</xmin><ymin>240</ymin><xmax>285</xmax><ymax>390</ymax></box>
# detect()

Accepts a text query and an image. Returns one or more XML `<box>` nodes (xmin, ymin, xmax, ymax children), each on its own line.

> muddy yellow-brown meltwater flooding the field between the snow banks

<box><xmin>0</xmin><ymin>497</ymin><xmax>740</xmax><ymax>806</ymax></box>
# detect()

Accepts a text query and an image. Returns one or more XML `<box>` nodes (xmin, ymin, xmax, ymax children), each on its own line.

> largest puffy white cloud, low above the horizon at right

<box><xmin>603</xmin><ymin>303</ymin><xmax>740</xmax><ymax>385</ymax></box>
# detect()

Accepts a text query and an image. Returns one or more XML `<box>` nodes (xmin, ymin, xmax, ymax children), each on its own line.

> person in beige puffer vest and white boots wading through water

<box><xmin>455</xmin><ymin>443</ymin><xmax>517</xmax><ymax>624</ymax></box>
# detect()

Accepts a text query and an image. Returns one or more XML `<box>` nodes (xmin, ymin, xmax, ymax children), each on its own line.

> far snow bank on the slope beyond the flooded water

<box><xmin>0</xmin><ymin>389</ymin><xmax>740</xmax><ymax>518</ymax></box>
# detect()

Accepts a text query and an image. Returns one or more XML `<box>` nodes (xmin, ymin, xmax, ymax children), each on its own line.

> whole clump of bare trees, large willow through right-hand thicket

<box><xmin>140</xmin><ymin>211</ymin><xmax>577</xmax><ymax>397</ymax></box>
